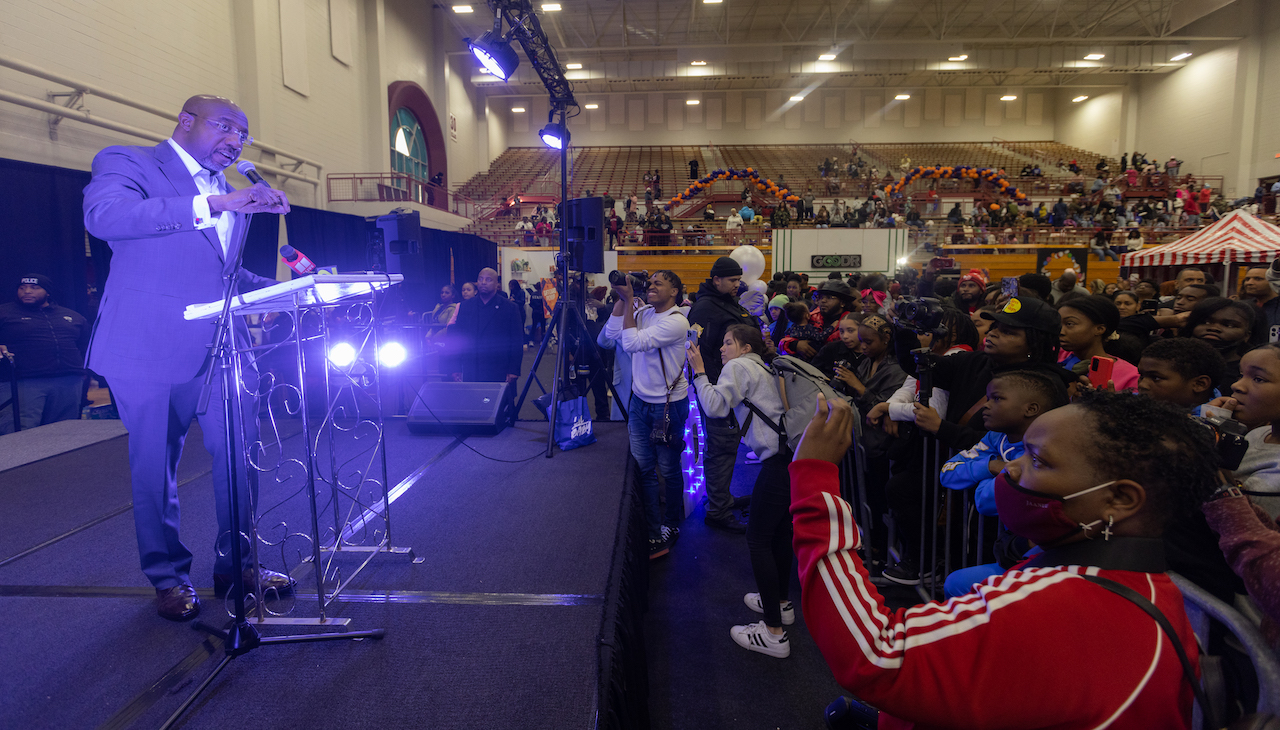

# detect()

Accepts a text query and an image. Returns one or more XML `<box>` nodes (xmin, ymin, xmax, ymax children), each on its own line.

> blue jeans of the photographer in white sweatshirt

<box><xmin>627</xmin><ymin>393</ymin><xmax>689</xmax><ymax>539</ymax></box>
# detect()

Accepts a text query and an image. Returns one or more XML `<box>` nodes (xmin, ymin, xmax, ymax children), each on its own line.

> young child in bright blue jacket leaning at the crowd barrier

<box><xmin>941</xmin><ymin>370</ymin><xmax>1068</xmax><ymax>597</ymax></box>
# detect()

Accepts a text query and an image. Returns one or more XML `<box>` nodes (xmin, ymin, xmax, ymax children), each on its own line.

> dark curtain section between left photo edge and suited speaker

<box><xmin>0</xmin><ymin>159</ymin><xmax>97</xmax><ymax>318</ymax></box>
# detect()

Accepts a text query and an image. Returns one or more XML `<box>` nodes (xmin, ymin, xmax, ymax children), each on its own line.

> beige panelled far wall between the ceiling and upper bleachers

<box><xmin>483</xmin><ymin>89</ymin><xmax>1055</xmax><ymax>147</ymax></box>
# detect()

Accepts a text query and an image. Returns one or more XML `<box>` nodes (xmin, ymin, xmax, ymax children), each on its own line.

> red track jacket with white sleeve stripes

<box><xmin>791</xmin><ymin>460</ymin><xmax>1198</xmax><ymax>730</ymax></box>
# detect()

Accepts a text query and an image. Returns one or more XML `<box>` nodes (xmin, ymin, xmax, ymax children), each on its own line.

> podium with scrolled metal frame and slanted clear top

<box><xmin>183</xmin><ymin>273</ymin><xmax>409</xmax><ymax>626</ymax></box>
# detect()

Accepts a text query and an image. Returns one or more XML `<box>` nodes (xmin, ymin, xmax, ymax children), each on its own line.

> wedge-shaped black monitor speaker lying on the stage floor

<box><xmin>408</xmin><ymin>382</ymin><xmax>511</xmax><ymax>435</ymax></box>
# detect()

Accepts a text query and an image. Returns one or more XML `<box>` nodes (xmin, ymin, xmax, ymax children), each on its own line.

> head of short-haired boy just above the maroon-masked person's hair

<box><xmin>1138</xmin><ymin>337</ymin><xmax>1226</xmax><ymax>410</ymax></box>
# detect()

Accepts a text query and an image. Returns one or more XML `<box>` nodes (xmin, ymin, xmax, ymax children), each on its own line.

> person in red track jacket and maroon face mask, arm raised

<box><xmin>790</xmin><ymin>392</ymin><xmax>1219</xmax><ymax>730</ymax></box>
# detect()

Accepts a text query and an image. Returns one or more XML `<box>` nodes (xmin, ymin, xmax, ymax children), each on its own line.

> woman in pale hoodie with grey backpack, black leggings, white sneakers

<box><xmin>687</xmin><ymin>324</ymin><xmax>795</xmax><ymax>658</ymax></box>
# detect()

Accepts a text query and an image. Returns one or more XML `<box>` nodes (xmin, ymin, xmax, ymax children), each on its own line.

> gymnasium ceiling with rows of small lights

<box><xmin>435</xmin><ymin>0</ymin><xmax>1243</xmax><ymax>96</ymax></box>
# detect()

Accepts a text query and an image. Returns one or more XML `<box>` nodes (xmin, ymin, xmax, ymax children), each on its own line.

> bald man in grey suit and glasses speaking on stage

<box><xmin>84</xmin><ymin>96</ymin><xmax>293</xmax><ymax>621</ymax></box>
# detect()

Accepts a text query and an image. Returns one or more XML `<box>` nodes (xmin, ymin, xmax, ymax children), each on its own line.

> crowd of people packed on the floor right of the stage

<box><xmin>568</xmin><ymin>251</ymin><xmax>1280</xmax><ymax>727</ymax></box>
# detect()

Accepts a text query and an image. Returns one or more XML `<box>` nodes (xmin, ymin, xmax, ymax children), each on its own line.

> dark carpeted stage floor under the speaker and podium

<box><xmin>0</xmin><ymin>420</ymin><xmax>648</xmax><ymax>730</ymax></box>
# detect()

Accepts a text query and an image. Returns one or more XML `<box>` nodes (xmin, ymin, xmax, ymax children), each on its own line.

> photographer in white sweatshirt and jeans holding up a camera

<box><xmin>604</xmin><ymin>269</ymin><xmax>689</xmax><ymax>558</ymax></box>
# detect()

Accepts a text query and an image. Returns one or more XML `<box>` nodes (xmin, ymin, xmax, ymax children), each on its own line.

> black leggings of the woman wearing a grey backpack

<box><xmin>746</xmin><ymin>451</ymin><xmax>795</xmax><ymax>628</ymax></box>
